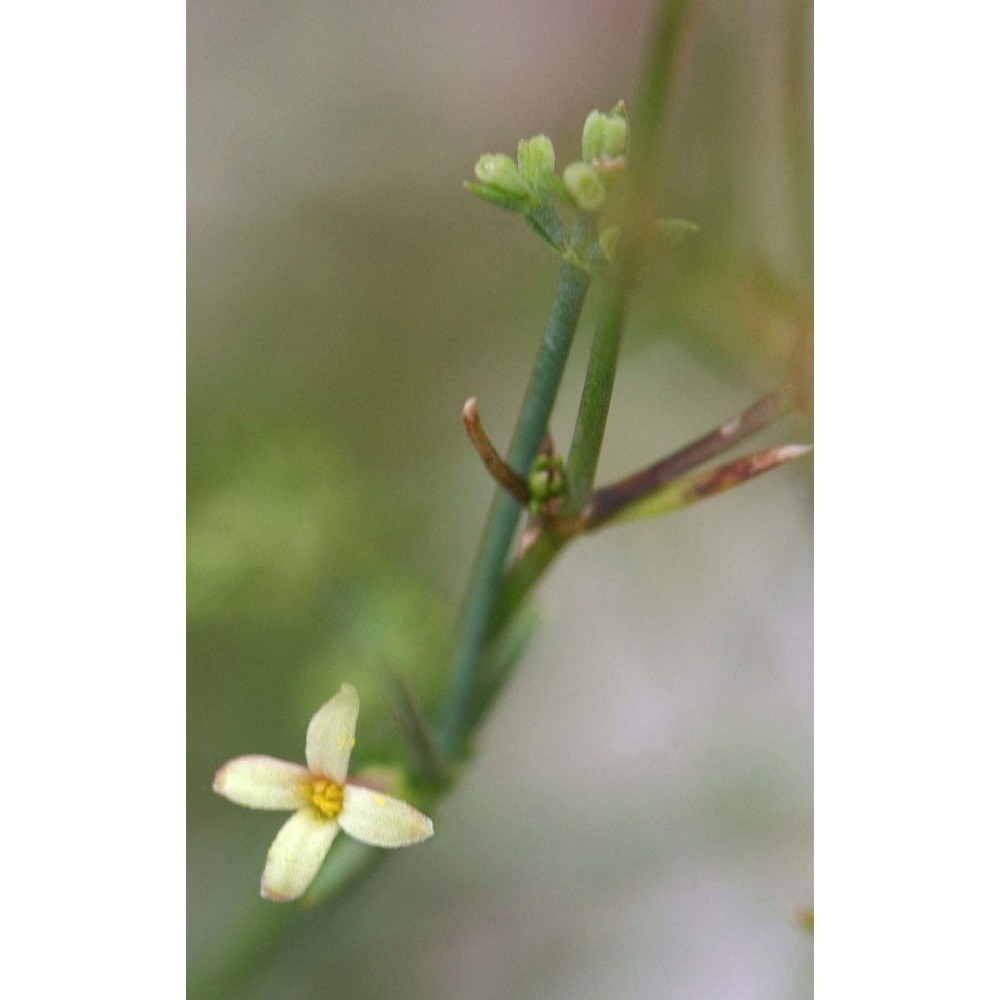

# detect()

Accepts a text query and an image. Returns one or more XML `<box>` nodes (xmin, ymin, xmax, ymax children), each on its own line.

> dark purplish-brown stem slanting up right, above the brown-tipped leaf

<box><xmin>586</xmin><ymin>386</ymin><xmax>792</xmax><ymax>529</ymax></box>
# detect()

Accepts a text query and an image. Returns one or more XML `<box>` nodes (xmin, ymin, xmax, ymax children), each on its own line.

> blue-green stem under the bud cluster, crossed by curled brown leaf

<box><xmin>441</xmin><ymin>261</ymin><xmax>590</xmax><ymax>756</ymax></box>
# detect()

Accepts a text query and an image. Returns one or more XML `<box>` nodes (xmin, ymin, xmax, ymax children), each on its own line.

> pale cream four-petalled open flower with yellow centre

<box><xmin>212</xmin><ymin>684</ymin><xmax>434</xmax><ymax>902</ymax></box>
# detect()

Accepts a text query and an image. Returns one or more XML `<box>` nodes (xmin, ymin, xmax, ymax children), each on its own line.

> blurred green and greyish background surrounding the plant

<box><xmin>188</xmin><ymin>0</ymin><xmax>812</xmax><ymax>1000</ymax></box>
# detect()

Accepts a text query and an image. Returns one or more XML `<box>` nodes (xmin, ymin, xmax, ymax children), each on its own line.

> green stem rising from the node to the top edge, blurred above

<box><xmin>566</xmin><ymin>0</ymin><xmax>690</xmax><ymax>512</ymax></box>
